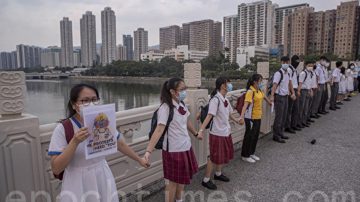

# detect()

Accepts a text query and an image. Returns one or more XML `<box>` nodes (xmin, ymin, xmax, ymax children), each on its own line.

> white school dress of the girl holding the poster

<box><xmin>48</xmin><ymin>118</ymin><xmax>120</xmax><ymax>202</ymax></box>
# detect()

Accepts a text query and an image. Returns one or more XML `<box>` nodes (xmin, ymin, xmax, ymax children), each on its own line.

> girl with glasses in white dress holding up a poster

<box><xmin>48</xmin><ymin>84</ymin><xmax>147</xmax><ymax>202</ymax></box>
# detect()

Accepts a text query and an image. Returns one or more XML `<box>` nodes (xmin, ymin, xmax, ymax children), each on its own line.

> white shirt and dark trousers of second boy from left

<box><xmin>285</xmin><ymin>65</ymin><xmax>299</xmax><ymax>129</ymax></box>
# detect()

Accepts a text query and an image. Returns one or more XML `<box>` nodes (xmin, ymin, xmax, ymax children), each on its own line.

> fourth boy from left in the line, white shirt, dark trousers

<box><xmin>311</xmin><ymin>56</ymin><xmax>327</xmax><ymax>118</ymax></box>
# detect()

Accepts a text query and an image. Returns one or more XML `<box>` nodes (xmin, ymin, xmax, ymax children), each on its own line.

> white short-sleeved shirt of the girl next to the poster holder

<box><xmin>157</xmin><ymin>100</ymin><xmax>191</xmax><ymax>152</ymax></box>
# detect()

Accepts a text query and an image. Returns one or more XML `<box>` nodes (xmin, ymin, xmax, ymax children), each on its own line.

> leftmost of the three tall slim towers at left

<box><xmin>60</xmin><ymin>17</ymin><xmax>74</xmax><ymax>67</ymax></box>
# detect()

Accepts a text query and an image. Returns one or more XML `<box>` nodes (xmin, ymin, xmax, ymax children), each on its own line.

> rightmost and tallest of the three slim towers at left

<box><xmin>101</xmin><ymin>7</ymin><xmax>116</xmax><ymax>65</ymax></box>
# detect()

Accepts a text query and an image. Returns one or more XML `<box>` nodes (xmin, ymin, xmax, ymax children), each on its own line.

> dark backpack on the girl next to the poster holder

<box><xmin>149</xmin><ymin>102</ymin><xmax>175</xmax><ymax>151</ymax></box>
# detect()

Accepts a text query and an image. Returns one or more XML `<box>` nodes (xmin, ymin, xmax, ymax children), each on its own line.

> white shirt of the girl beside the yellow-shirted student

<box><xmin>208</xmin><ymin>92</ymin><xmax>233</xmax><ymax>137</ymax></box>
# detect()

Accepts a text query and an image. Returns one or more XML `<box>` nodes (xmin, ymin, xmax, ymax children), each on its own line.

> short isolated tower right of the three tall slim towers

<box><xmin>134</xmin><ymin>28</ymin><xmax>149</xmax><ymax>61</ymax></box>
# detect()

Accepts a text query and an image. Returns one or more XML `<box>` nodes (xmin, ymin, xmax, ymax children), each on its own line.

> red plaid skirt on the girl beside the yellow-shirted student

<box><xmin>209</xmin><ymin>134</ymin><xmax>234</xmax><ymax>165</ymax></box>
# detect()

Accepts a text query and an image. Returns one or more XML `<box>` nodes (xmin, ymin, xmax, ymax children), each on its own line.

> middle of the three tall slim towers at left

<box><xmin>80</xmin><ymin>11</ymin><xmax>96</xmax><ymax>67</ymax></box>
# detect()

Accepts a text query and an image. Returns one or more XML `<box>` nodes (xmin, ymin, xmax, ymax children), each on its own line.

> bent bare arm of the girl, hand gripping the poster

<box><xmin>51</xmin><ymin>128</ymin><xmax>89</xmax><ymax>175</ymax></box>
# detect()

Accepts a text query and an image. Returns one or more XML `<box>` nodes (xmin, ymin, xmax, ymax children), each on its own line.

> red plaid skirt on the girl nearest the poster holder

<box><xmin>162</xmin><ymin>148</ymin><xmax>199</xmax><ymax>184</ymax></box>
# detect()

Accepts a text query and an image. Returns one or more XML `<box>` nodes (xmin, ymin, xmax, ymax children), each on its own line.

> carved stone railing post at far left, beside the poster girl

<box><xmin>0</xmin><ymin>71</ymin><xmax>44</xmax><ymax>201</ymax></box>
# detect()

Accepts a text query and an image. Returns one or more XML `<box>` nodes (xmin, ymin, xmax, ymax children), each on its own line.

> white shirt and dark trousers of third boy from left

<box><xmin>299</xmin><ymin>70</ymin><xmax>312</xmax><ymax>125</ymax></box>
